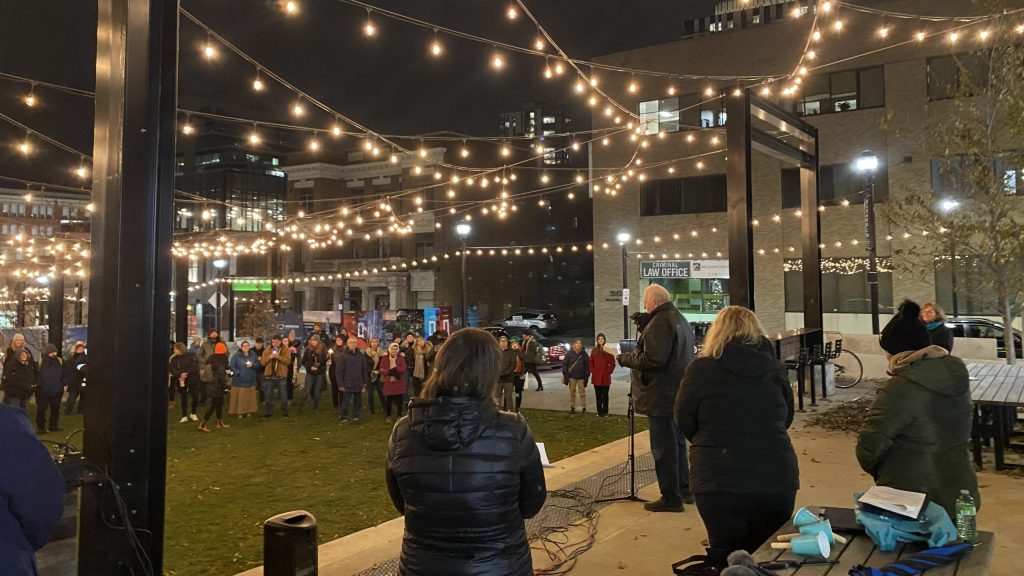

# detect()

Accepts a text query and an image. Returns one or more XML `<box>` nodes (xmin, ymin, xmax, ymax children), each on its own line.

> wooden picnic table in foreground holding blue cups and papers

<box><xmin>753</xmin><ymin>507</ymin><xmax>995</xmax><ymax>576</ymax></box>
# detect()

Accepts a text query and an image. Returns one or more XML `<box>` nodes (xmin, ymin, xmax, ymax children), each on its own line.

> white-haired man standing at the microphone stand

<box><xmin>617</xmin><ymin>284</ymin><xmax>693</xmax><ymax>512</ymax></box>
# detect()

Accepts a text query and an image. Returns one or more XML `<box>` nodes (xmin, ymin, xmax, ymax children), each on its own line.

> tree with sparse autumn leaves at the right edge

<box><xmin>888</xmin><ymin>17</ymin><xmax>1024</xmax><ymax>364</ymax></box>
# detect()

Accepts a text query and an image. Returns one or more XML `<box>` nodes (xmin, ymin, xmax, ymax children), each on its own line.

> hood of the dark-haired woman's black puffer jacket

<box><xmin>409</xmin><ymin>396</ymin><xmax>498</xmax><ymax>451</ymax></box>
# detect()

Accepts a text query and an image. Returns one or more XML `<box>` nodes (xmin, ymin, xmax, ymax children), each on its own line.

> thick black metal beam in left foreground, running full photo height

<box><xmin>79</xmin><ymin>0</ymin><xmax>178</xmax><ymax>576</ymax></box>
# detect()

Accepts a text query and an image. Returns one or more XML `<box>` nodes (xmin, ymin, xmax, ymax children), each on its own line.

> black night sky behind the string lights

<box><xmin>0</xmin><ymin>0</ymin><xmax>714</xmax><ymax>186</ymax></box>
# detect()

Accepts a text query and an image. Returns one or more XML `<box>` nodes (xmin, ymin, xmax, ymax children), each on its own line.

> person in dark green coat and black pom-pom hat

<box><xmin>857</xmin><ymin>300</ymin><xmax>981</xmax><ymax>519</ymax></box>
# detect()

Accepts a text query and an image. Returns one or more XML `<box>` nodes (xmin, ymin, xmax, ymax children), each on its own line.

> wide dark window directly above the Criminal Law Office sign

<box><xmin>640</xmin><ymin>174</ymin><xmax>726</xmax><ymax>216</ymax></box>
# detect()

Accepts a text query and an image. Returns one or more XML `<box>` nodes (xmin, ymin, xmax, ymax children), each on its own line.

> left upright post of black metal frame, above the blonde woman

<box><xmin>725</xmin><ymin>90</ymin><xmax>754</xmax><ymax>310</ymax></box>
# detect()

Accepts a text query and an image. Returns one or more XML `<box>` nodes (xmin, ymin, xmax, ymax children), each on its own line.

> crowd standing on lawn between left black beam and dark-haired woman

<box><xmin>167</xmin><ymin>326</ymin><xmax>447</xmax><ymax>431</ymax></box>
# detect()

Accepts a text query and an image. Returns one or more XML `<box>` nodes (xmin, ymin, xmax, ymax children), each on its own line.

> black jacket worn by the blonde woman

<box><xmin>676</xmin><ymin>338</ymin><xmax>800</xmax><ymax>494</ymax></box>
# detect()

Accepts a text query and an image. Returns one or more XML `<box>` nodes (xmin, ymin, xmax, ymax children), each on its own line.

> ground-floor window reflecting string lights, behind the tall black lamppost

<box><xmin>783</xmin><ymin>258</ymin><xmax>893</xmax><ymax>314</ymax></box>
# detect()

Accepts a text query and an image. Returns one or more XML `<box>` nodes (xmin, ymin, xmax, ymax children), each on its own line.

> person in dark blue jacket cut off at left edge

<box><xmin>0</xmin><ymin>405</ymin><xmax>65</xmax><ymax>576</ymax></box>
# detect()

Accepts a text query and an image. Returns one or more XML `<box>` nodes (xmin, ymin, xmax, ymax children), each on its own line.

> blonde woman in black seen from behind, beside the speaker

<box><xmin>676</xmin><ymin>306</ymin><xmax>800</xmax><ymax>568</ymax></box>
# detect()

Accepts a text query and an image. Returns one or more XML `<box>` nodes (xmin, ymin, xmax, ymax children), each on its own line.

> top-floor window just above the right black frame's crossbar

<box><xmin>794</xmin><ymin>67</ymin><xmax>886</xmax><ymax>116</ymax></box>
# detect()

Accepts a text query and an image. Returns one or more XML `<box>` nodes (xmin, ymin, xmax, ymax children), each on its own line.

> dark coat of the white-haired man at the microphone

<box><xmin>617</xmin><ymin>302</ymin><xmax>693</xmax><ymax>416</ymax></box>
